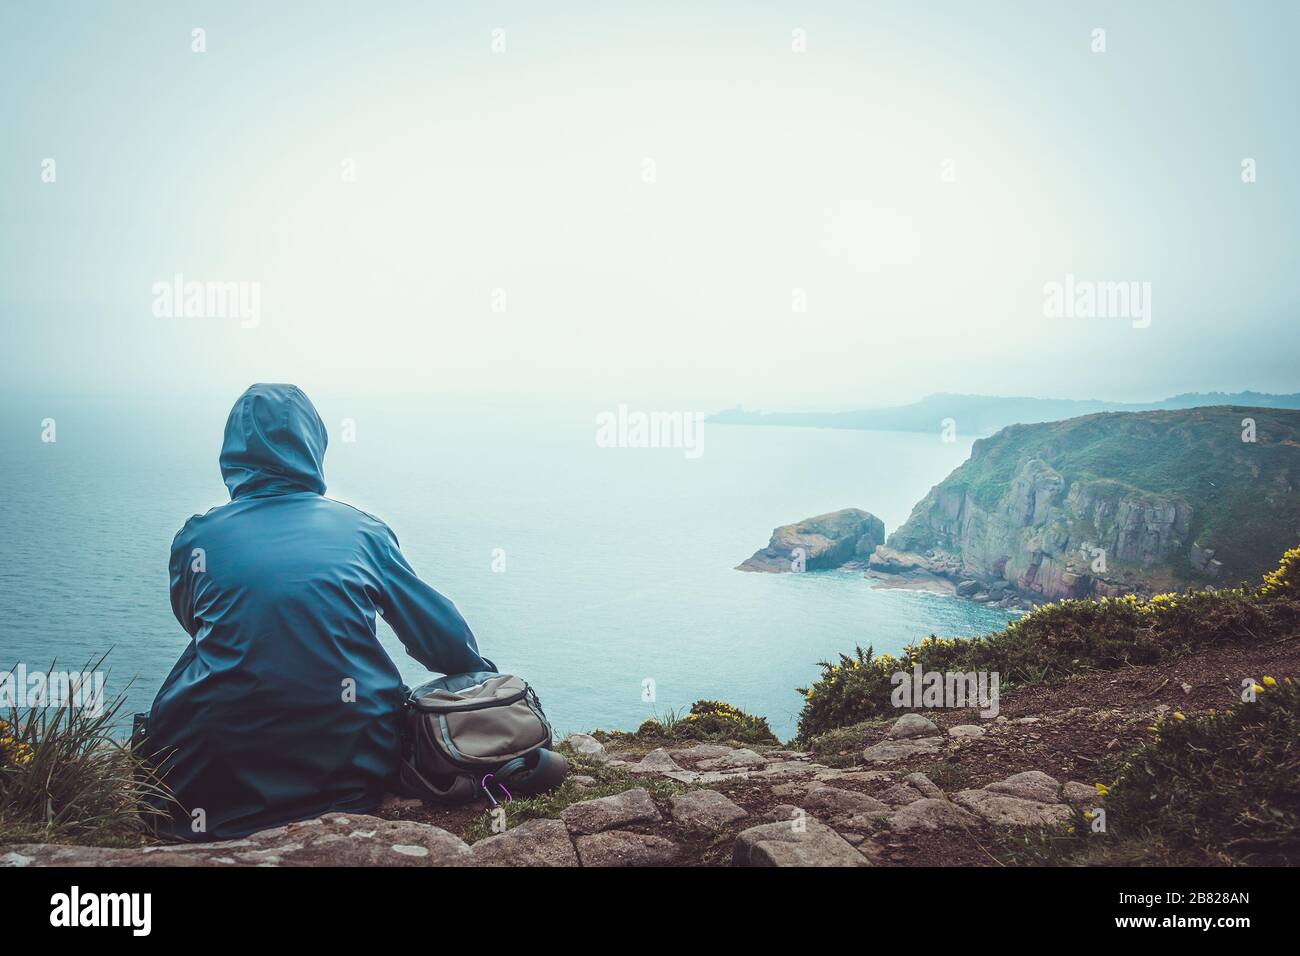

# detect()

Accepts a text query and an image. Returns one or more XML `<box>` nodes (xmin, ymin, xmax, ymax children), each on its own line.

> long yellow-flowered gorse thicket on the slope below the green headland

<box><xmin>797</xmin><ymin>548</ymin><xmax>1300</xmax><ymax>744</ymax></box>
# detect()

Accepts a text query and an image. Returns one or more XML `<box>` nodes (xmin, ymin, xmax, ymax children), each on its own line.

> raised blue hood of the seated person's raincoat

<box><xmin>221</xmin><ymin>385</ymin><xmax>329</xmax><ymax>501</ymax></box>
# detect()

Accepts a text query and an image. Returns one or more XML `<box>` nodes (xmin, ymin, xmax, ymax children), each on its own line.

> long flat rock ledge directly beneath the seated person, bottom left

<box><xmin>0</xmin><ymin>813</ymin><xmax>473</xmax><ymax>866</ymax></box>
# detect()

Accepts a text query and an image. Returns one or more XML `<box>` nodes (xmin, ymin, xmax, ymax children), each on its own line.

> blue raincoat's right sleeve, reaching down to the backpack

<box><xmin>380</xmin><ymin>532</ymin><xmax>497</xmax><ymax>674</ymax></box>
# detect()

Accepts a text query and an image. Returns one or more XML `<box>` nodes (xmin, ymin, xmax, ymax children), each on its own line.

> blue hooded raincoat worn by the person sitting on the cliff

<box><xmin>148</xmin><ymin>385</ymin><xmax>495</xmax><ymax>839</ymax></box>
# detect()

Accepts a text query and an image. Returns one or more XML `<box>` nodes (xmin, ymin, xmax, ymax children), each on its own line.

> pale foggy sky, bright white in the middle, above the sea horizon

<box><xmin>0</xmin><ymin>1</ymin><xmax>1300</xmax><ymax>410</ymax></box>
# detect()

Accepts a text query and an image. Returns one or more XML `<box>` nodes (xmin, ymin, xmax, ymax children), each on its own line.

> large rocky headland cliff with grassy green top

<box><xmin>870</xmin><ymin>407</ymin><xmax>1300</xmax><ymax>600</ymax></box>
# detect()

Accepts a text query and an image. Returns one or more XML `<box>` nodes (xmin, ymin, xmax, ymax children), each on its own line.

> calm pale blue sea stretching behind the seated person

<box><xmin>0</xmin><ymin>395</ymin><xmax>1008</xmax><ymax>737</ymax></box>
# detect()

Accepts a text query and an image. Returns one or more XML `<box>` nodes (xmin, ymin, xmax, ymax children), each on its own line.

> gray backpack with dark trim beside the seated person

<box><xmin>402</xmin><ymin>671</ymin><xmax>568</xmax><ymax>805</ymax></box>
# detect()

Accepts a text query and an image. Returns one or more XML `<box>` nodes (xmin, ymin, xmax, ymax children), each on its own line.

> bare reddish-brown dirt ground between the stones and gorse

<box><xmin>380</xmin><ymin>637</ymin><xmax>1300</xmax><ymax>866</ymax></box>
